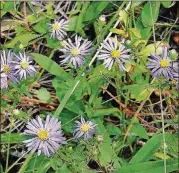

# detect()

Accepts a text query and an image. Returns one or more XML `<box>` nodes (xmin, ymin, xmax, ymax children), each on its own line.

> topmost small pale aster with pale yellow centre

<box><xmin>49</xmin><ymin>19</ymin><xmax>68</xmax><ymax>40</ymax></box>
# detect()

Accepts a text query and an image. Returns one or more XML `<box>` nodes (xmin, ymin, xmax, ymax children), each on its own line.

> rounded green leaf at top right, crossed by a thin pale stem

<box><xmin>141</xmin><ymin>1</ymin><xmax>160</xmax><ymax>27</ymax></box>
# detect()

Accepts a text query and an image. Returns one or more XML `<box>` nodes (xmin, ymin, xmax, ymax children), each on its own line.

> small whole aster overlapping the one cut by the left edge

<box><xmin>13</xmin><ymin>52</ymin><xmax>36</xmax><ymax>79</ymax></box>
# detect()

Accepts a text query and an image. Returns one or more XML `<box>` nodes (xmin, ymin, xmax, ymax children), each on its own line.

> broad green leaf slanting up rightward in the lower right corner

<box><xmin>129</xmin><ymin>133</ymin><xmax>172</xmax><ymax>164</ymax></box>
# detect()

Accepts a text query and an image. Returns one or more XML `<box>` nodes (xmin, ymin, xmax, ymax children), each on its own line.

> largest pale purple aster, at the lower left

<box><xmin>23</xmin><ymin>115</ymin><xmax>66</xmax><ymax>157</ymax></box>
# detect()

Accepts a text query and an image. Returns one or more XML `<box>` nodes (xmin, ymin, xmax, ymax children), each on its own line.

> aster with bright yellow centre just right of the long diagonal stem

<box><xmin>98</xmin><ymin>36</ymin><xmax>131</xmax><ymax>71</ymax></box>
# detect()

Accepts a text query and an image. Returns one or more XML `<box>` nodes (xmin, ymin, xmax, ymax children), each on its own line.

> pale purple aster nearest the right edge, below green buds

<box><xmin>147</xmin><ymin>46</ymin><xmax>173</xmax><ymax>80</ymax></box>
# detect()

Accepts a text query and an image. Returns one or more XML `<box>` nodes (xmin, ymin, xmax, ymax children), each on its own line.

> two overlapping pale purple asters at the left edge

<box><xmin>0</xmin><ymin>50</ymin><xmax>36</xmax><ymax>89</ymax></box>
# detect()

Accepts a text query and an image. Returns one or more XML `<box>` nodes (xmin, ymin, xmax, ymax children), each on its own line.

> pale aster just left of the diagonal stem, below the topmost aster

<box><xmin>60</xmin><ymin>35</ymin><xmax>92</xmax><ymax>68</ymax></box>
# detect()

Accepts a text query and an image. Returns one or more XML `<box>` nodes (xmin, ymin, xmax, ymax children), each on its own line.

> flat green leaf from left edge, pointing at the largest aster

<box><xmin>1</xmin><ymin>133</ymin><xmax>30</xmax><ymax>144</ymax></box>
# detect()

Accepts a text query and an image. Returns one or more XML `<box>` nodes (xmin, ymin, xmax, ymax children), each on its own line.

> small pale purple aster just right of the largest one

<box><xmin>73</xmin><ymin>116</ymin><xmax>97</xmax><ymax>141</ymax></box>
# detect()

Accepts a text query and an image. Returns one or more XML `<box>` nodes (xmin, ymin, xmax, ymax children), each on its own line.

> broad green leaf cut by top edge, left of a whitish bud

<box><xmin>83</xmin><ymin>2</ymin><xmax>109</xmax><ymax>22</ymax></box>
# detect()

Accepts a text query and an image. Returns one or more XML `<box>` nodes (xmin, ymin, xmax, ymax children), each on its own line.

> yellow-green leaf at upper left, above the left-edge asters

<box><xmin>5</xmin><ymin>33</ymin><xmax>39</xmax><ymax>48</ymax></box>
